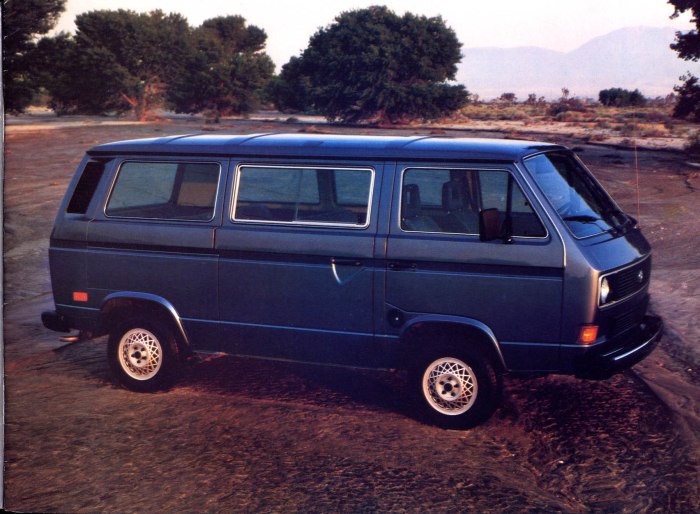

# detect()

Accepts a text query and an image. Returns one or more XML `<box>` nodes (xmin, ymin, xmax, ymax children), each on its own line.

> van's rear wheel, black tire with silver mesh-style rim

<box><xmin>107</xmin><ymin>318</ymin><xmax>182</xmax><ymax>392</ymax></box>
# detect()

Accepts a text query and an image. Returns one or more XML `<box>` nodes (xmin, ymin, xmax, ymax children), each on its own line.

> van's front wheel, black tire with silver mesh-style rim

<box><xmin>409</xmin><ymin>345</ymin><xmax>502</xmax><ymax>430</ymax></box>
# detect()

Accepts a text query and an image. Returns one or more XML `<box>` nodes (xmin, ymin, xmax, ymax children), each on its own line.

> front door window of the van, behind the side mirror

<box><xmin>401</xmin><ymin>168</ymin><xmax>546</xmax><ymax>237</ymax></box>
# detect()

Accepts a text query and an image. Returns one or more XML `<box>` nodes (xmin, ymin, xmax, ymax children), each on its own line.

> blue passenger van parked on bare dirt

<box><xmin>42</xmin><ymin>134</ymin><xmax>662</xmax><ymax>428</ymax></box>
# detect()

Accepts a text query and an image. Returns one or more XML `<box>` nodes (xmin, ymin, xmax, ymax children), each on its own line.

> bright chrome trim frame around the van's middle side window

<box><xmin>229</xmin><ymin>162</ymin><xmax>377</xmax><ymax>230</ymax></box>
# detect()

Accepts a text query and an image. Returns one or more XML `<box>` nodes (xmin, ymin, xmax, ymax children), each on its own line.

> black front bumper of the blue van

<box><xmin>574</xmin><ymin>315</ymin><xmax>663</xmax><ymax>379</ymax></box>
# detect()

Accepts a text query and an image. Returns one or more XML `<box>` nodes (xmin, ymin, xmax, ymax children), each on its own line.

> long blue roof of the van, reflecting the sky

<box><xmin>88</xmin><ymin>134</ymin><xmax>564</xmax><ymax>162</ymax></box>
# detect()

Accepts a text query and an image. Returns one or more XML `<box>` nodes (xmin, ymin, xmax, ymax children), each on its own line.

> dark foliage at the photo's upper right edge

<box><xmin>668</xmin><ymin>0</ymin><xmax>700</xmax><ymax>122</ymax></box>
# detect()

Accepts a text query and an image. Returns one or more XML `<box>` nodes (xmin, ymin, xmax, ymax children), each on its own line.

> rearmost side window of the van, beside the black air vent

<box><xmin>105</xmin><ymin>162</ymin><xmax>220</xmax><ymax>221</ymax></box>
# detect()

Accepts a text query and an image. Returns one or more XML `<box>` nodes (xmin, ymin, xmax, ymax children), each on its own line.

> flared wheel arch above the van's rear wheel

<box><xmin>99</xmin><ymin>291</ymin><xmax>191</xmax><ymax>352</ymax></box>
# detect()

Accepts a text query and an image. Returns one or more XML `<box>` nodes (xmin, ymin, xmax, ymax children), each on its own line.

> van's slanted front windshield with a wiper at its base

<box><xmin>525</xmin><ymin>148</ymin><xmax>631</xmax><ymax>238</ymax></box>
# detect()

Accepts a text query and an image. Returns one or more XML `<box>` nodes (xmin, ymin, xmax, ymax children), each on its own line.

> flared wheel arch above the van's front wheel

<box><xmin>400</xmin><ymin>315</ymin><xmax>508</xmax><ymax>371</ymax></box>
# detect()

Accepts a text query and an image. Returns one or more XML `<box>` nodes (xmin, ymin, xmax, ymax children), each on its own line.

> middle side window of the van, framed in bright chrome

<box><xmin>233</xmin><ymin>166</ymin><xmax>374</xmax><ymax>226</ymax></box>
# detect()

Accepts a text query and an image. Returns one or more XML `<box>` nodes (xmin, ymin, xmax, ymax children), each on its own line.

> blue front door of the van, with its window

<box><xmin>386</xmin><ymin>163</ymin><xmax>564</xmax><ymax>370</ymax></box>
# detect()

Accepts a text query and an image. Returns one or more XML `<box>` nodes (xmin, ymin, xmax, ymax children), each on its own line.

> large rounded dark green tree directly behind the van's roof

<box><xmin>278</xmin><ymin>6</ymin><xmax>468</xmax><ymax>123</ymax></box>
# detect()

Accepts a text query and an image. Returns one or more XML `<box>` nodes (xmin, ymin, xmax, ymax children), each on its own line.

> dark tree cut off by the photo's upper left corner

<box><xmin>2</xmin><ymin>0</ymin><xmax>66</xmax><ymax>113</ymax></box>
